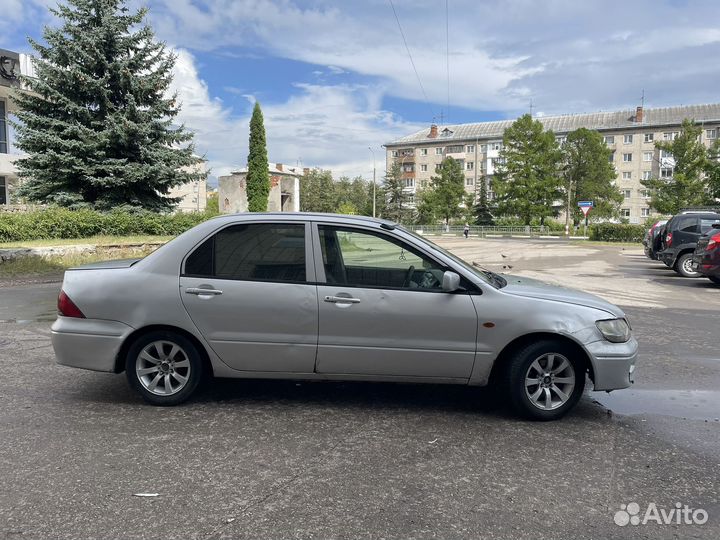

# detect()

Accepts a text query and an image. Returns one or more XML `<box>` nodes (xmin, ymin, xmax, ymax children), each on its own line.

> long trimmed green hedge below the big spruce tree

<box><xmin>0</xmin><ymin>207</ymin><xmax>212</xmax><ymax>242</ymax></box>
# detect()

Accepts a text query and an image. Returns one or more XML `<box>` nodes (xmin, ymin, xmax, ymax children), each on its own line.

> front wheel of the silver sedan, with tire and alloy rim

<box><xmin>504</xmin><ymin>340</ymin><xmax>585</xmax><ymax>421</ymax></box>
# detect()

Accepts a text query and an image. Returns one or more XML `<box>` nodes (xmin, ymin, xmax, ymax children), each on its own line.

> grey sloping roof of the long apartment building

<box><xmin>385</xmin><ymin>103</ymin><xmax>720</xmax><ymax>146</ymax></box>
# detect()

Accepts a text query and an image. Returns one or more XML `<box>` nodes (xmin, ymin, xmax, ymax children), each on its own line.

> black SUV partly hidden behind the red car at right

<box><xmin>658</xmin><ymin>212</ymin><xmax>720</xmax><ymax>277</ymax></box>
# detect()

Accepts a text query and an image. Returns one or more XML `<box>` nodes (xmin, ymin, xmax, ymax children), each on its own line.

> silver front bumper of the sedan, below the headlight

<box><xmin>585</xmin><ymin>337</ymin><xmax>638</xmax><ymax>390</ymax></box>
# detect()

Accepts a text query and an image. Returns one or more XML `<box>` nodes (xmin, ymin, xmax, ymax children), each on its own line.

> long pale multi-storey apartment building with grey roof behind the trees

<box><xmin>384</xmin><ymin>104</ymin><xmax>720</xmax><ymax>223</ymax></box>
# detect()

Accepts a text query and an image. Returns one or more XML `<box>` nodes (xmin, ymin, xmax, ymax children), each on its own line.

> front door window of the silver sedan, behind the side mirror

<box><xmin>318</xmin><ymin>225</ymin><xmax>445</xmax><ymax>291</ymax></box>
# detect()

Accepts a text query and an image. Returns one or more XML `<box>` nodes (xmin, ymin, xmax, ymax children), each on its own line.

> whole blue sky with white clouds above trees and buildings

<box><xmin>0</xmin><ymin>0</ymin><xmax>720</xmax><ymax>184</ymax></box>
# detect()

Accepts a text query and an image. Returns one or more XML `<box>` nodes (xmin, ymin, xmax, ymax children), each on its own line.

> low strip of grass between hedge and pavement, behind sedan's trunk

<box><xmin>0</xmin><ymin>249</ymin><xmax>159</xmax><ymax>279</ymax></box>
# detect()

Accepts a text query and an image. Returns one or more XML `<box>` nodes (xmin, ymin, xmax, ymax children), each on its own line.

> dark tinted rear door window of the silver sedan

<box><xmin>185</xmin><ymin>223</ymin><xmax>306</xmax><ymax>282</ymax></box>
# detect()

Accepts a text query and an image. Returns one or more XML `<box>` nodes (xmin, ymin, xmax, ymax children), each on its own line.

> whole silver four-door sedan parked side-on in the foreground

<box><xmin>52</xmin><ymin>213</ymin><xmax>638</xmax><ymax>420</ymax></box>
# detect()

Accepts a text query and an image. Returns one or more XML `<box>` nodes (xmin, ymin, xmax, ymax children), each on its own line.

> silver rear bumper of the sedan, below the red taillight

<box><xmin>51</xmin><ymin>317</ymin><xmax>133</xmax><ymax>372</ymax></box>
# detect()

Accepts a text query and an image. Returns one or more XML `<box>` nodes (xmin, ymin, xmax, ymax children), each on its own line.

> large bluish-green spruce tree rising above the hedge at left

<box><xmin>14</xmin><ymin>0</ymin><xmax>206</xmax><ymax>211</ymax></box>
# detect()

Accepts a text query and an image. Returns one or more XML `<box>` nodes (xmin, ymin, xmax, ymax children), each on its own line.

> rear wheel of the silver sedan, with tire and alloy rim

<box><xmin>125</xmin><ymin>331</ymin><xmax>203</xmax><ymax>406</ymax></box>
